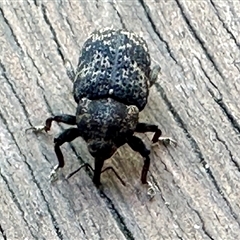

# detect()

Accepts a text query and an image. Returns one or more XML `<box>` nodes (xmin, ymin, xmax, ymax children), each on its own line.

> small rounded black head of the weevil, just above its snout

<box><xmin>88</xmin><ymin>140</ymin><xmax>117</xmax><ymax>160</ymax></box>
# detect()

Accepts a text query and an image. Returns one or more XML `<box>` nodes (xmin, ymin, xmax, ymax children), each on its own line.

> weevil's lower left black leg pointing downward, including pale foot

<box><xmin>50</xmin><ymin>128</ymin><xmax>80</xmax><ymax>181</ymax></box>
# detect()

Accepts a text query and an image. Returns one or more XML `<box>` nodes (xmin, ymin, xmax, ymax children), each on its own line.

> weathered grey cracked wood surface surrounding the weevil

<box><xmin>0</xmin><ymin>0</ymin><xmax>240</xmax><ymax>240</ymax></box>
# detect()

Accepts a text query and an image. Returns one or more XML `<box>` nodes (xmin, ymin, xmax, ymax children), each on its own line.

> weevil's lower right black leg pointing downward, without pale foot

<box><xmin>127</xmin><ymin>136</ymin><xmax>150</xmax><ymax>184</ymax></box>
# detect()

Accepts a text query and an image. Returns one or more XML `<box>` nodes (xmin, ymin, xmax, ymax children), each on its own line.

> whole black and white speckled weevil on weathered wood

<box><xmin>31</xmin><ymin>30</ymin><xmax>174</xmax><ymax>186</ymax></box>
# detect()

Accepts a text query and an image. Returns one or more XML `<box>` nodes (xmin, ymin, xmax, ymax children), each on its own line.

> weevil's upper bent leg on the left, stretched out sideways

<box><xmin>26</xmin><ymin>114</ymin><xmax>76</xmax><ymax>132</ymax></box>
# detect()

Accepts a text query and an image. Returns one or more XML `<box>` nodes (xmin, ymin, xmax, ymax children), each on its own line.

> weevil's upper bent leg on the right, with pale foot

<box><xmin>135</xmin><ymin>123</ymin><xmax>177</xmax><ymax>146</ymax></box>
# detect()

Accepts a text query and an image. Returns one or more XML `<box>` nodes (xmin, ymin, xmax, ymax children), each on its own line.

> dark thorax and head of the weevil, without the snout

<box><xmin>76</xmin><ymin>98</ymin><xmax>139</xmax><ymax>159</ymax></box>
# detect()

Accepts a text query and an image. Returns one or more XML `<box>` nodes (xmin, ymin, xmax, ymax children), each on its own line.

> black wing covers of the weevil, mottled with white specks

<box><xmin>74</xmin><ymin>30</ymin><xmax>151</xmax><ymax>111</ymax></box>
